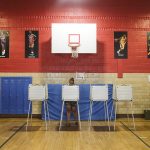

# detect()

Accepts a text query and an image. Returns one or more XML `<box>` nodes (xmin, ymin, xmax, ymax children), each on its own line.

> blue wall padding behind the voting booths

<box><xmin>42</xmin><ymin>84</ymin><xmax>114</xmax><ymax>120</ymax></box>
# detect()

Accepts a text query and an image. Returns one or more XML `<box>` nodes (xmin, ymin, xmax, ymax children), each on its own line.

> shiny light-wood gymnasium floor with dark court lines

<box><xmin>0</xmin><ymin>118</ymin><xmax>150</xmax><ymax>150</ymax></box>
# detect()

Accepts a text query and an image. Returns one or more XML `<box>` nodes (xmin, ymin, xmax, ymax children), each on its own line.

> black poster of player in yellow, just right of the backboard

<box><xmin>114</xmin><ymin>31</ymin><xmax>128</xmax><ymax>59</ymax></box>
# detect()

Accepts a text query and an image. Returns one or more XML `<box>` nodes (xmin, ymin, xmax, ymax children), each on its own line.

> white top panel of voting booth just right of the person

<box><xmin>90</xmin><ymin>85</ymin><xmax>108</xmax><ymax>101</ymax></box>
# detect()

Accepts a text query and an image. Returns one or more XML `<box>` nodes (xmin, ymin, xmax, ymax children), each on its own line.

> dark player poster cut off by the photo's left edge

<box><xmin>0</xmin><ymin>30</ymin><xmax>9</xmax><ymax>58</ymax></box>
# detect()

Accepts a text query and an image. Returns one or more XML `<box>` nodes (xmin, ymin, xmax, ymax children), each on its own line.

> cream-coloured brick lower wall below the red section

<box><xmin>0</xmin><ymin>73</ymin><xmax>150</xmax><ymax>114</ymax></box>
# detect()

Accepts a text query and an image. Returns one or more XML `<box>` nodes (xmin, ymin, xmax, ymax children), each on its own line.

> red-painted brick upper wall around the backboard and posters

<box><xmin>0</xmin><ymin>0</ymin><xmax>150</xmax><ymax>76</ymax></box>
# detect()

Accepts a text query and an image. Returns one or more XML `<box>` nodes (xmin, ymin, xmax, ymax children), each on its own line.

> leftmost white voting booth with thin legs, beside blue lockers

<box><xmin>26</xmin><ymin>84</ymin><xmax>50</xmax><ymax>130</ymax></box>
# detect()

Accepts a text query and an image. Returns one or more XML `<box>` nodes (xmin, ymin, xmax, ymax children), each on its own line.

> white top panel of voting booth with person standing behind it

<box><xmin>62</xmin><ymin>85</ymin><xmax>79</xmax><ymax>101</ymax></box>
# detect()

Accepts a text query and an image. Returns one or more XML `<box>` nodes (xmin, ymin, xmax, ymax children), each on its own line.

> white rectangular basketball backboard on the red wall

<box><xmin>51</xmin><ymin>23</ymin><xmax>97</xmax><ymax>54</ymax></box>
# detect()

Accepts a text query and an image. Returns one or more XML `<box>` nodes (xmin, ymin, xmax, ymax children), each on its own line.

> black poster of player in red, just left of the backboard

<box><xmin>25</xmin><ymin>30</ymin><xmax>39</xmax><ymax>58</ymax></box>
